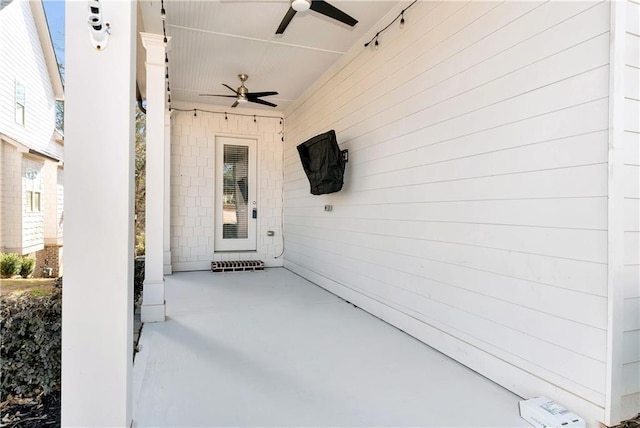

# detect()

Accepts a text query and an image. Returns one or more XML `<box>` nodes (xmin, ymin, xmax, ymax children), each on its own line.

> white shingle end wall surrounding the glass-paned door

<box><xmin>171</xmin><ymin>107</ymin><xmax>283</xmax><ymax>271</ymax></box>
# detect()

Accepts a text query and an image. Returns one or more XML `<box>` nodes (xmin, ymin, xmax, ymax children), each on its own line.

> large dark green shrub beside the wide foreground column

<box><xmin>0</xmin><ymin>288</ymin><xmax>62</xmax><ymax>401</ymax></box>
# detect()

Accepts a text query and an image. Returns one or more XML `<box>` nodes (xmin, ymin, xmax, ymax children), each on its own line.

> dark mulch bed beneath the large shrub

<box><xmin>0</xmin><ymin>391</ymin><xmax>60</xmax><ymax>428</ymax></box>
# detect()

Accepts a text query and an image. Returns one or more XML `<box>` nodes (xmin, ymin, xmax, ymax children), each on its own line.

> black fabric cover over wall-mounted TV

<box><xmin>298</xmin><ymin>130</ymin><xmax>345</xmax><ymax>195</ymax></box>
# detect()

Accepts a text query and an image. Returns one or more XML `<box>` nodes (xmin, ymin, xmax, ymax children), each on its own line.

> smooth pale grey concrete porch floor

<box><xmin>133</xmin><ymin>268</ymin><xmax>530</xmax><ymax>427</ymax></box>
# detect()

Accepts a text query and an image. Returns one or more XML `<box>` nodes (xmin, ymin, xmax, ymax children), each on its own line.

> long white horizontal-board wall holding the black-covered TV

<box><xmin>285</xmin><ymin>1</ymin><xmax>609</xmax><ymax>424</ymax></box>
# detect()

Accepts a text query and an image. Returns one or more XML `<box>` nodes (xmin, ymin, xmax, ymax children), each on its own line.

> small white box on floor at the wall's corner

<box><xmin>519</xmin><ymin>397</ymin><xmax>587</xmax><ymax>428</ymax></box>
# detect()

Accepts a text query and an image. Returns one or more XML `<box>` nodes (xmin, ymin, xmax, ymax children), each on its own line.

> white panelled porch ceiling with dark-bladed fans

<box><xmin>138</xmin><ymin>0</ymin><xmax>399</xmax><ymax>111</ymax></box>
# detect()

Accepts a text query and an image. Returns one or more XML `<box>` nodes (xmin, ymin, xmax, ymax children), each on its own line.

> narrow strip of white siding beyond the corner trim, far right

<box><xmin>622</xmin><ymin>1</ymin><xmax>640</xmax><ymax>418</ymax></box>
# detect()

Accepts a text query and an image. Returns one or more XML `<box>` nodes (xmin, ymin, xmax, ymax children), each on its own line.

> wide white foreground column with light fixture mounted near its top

<box><xmin>62</xmin><ymin>1</ymin><xmax>137</xmax><ymax>427</ymax></box>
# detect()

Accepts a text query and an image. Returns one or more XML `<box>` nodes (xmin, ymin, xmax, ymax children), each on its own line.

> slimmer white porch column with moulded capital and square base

<box><xmin>140</xmin><ymin>33</ymin><xmax>168</xmax><ymax>322</ymax></box>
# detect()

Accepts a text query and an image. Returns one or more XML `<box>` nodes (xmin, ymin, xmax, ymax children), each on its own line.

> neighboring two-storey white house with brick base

<box><xmin>0</xmin><ymin>0</ymin><xmax>64</xmax><ymax>276</ymax></box>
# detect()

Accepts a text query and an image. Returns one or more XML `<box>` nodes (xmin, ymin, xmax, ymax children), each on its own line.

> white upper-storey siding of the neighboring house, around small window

<box><xmin>0</xmin><ymin>0</ymin><xmax>63</xmax><ymax>158</ymax></box>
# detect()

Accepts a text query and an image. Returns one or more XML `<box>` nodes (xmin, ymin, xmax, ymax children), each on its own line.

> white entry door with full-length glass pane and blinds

<box><xmin>214</xmin><ymin>137</ymin><xmax>259</xmax><ymax>251</ymax></box>
